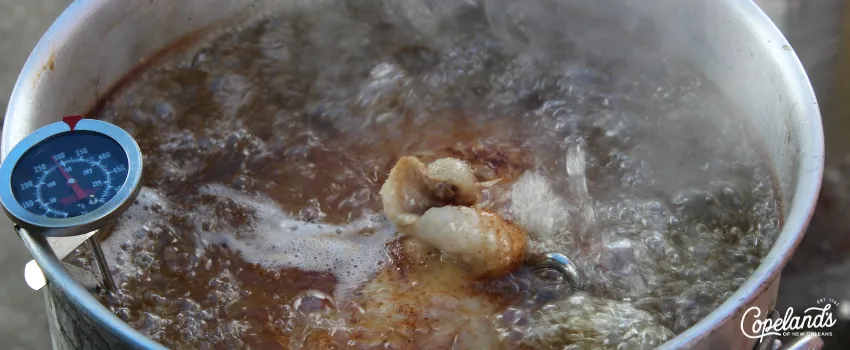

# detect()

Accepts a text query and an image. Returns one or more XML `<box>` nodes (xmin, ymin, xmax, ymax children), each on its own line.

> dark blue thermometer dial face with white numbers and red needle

<box><xmin>11</xmin><ymin>130</ymin><xmax>129</xmax><ymax>219</ymax></box>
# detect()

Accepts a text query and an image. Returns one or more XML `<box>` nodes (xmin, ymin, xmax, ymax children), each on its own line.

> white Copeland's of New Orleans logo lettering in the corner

<box><xmin>741</xmin><ymin>298</ymin><xmax>838</xmax><ymax>342</ymax></box>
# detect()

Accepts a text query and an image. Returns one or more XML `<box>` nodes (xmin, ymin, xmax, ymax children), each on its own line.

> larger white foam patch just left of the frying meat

<box><xmin>198</xmin><ymin>185</ymin><xmax>395</xmax><ymax>300</ymax></box>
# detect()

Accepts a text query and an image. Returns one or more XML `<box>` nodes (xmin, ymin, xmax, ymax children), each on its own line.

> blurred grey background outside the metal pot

<box><xmin>0</xmin><ymin>0</ymin><xmax>850</xmax><ymax>349</ymax></box>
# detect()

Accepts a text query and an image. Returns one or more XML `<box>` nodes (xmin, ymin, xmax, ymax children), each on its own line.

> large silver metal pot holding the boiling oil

<box><xmin>2</xmin><ymin>0</ymin><xmax>823</xmax><ymax>349</ymax></box>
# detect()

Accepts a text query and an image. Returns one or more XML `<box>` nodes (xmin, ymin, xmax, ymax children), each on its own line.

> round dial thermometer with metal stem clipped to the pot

<box><xmin>0</xmin><ymin>116</ymin><xmax>142</xmax><ymax>290</ymax></box>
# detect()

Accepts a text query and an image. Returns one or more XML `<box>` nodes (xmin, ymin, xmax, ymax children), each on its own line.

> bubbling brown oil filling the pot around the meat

<box><xmin>69</xmin><ymin>1</ymin><xmax>780</xmax><ymax>348</ymax></box>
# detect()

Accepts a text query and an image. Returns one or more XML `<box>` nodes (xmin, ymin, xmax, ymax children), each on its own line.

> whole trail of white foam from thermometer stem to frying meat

<box><xmin>104</xmin><ymin>184</ymin><xmax>395</xmax><ymax>300</ymax></box>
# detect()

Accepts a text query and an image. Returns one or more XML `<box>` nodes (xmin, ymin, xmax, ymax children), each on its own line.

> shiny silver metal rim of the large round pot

<box><xmin>0</xmin><ymin>0</ymin><xmax>824</xmax><ymax>349</ymax></box>
